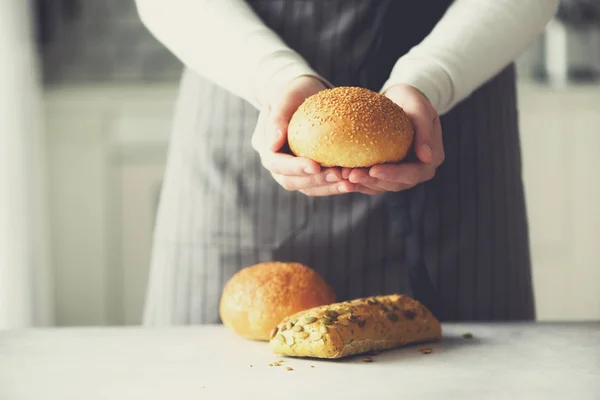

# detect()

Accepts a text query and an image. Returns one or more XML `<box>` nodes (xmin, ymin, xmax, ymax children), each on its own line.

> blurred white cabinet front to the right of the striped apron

<box><xmin>520</xmin><ymin>84</ymin><xmax>600</xmax><ymax>320</ymax></box>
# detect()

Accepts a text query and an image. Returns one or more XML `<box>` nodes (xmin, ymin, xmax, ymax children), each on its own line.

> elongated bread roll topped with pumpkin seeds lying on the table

<box><xmin>269</xmin><ymin>294</ymin><xmax>442</xmax><ymax>359</ymax></box>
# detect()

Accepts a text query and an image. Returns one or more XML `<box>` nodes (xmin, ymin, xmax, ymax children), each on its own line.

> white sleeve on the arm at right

<box><xmin>382</xmin><ymin>0</ymin><xmax>559</xmax><ymax>114</ymax></box>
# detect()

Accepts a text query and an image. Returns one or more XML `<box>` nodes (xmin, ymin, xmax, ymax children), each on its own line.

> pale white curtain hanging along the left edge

<box><xmin>0</xmin><ymin>0</ymin><xmax>55</xmax><ymax>329</ymax></box>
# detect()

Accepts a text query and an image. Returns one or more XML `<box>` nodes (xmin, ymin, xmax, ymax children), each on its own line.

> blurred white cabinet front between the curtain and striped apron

<box><xmin>46</xmin><ymin>86</ymin><xmax>176</xmax><ymax>325</ymax></box>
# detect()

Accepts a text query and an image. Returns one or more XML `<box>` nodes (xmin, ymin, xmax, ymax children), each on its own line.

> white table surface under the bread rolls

<box><xmin>0</xmin><ymin>323</ymin><xmax>600</xmax><ymax>400</ymax></box>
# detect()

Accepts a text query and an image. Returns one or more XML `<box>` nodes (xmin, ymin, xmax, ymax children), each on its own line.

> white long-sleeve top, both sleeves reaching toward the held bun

<box><xmin>136</xmin><ymin>0</ymin><xmax>558</xmax><ymax>114</ymax></box>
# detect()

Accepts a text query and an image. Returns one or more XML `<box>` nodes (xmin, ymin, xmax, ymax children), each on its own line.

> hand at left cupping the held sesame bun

<box><xmin>252</xmin><ymin>76</ymin><xmax>358</xmax><ymax>196</ymax></box>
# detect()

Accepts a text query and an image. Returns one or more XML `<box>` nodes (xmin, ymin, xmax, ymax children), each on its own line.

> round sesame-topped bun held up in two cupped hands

<box><xmin>288</xmin><ymin>87</ymin><xmax>414</xmax><ymax>168</ymax></box>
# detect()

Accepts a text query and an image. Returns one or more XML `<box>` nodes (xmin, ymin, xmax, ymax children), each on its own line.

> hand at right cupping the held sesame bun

<box><xmin>342</xmin><ymin>84</ymin><xmax>445</xmax><ymax>193</ymax></box>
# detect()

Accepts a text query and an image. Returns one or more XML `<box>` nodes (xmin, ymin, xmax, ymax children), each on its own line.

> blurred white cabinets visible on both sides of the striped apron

<box><xmin>46</xmin><ymin>84</ymin><xmax>600</xmax><ymax>325</ymax></box>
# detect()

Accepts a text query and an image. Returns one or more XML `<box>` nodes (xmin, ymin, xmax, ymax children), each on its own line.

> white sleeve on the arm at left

<box><xmin>136</xmin><ymin>0</ymin><xmax>328</xmax><ymax>108</ymax></box>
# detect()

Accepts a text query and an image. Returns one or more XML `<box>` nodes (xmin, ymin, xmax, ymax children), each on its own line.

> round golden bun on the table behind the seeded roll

<box><xmin>220</xmin><ymin>262</ymin><xmax>335</xmax><ymax>341</ymax></box>
